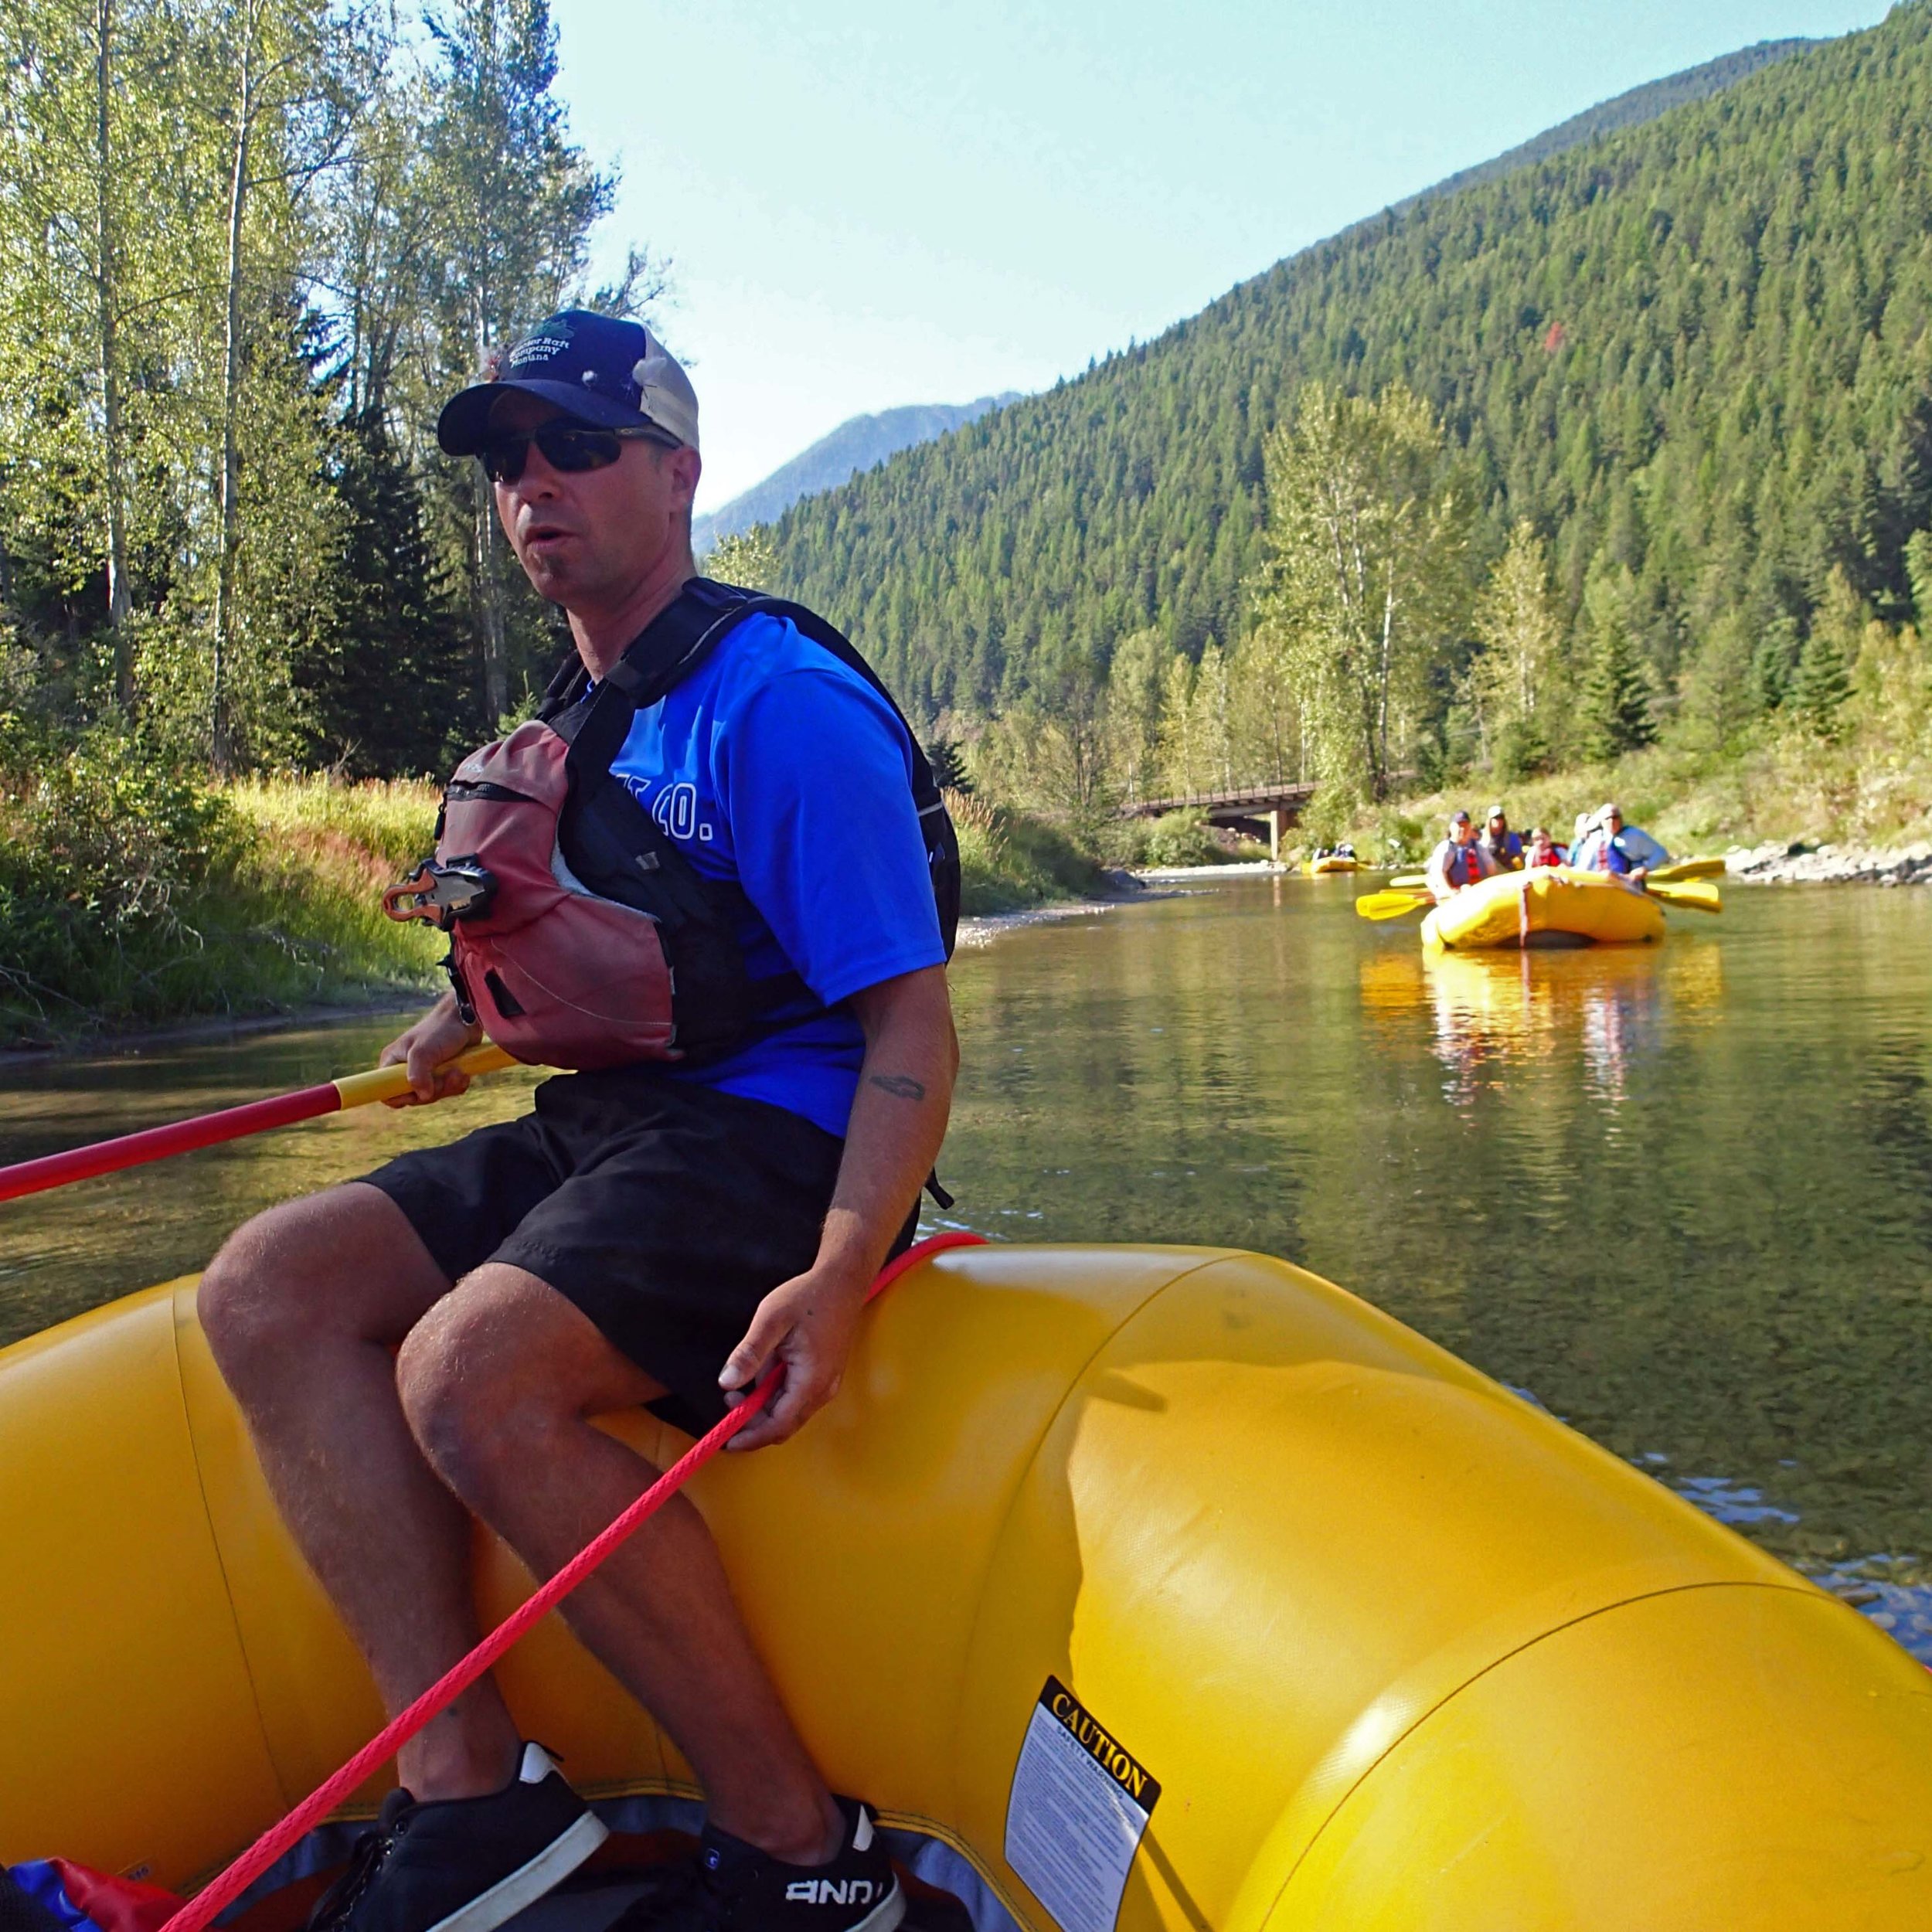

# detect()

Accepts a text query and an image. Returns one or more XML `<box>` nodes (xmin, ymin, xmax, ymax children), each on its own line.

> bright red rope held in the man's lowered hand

<box><xmin>162</xmin><ymin>1231</ymin><xmax>985</xmax><ymax>1932</ymax></box>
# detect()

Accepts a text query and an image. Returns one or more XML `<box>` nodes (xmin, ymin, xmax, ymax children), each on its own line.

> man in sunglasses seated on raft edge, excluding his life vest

<box><xmin>201</xmin><ymin>311</ymin><xmax>958</xmax><ymax>1932</ymax></box>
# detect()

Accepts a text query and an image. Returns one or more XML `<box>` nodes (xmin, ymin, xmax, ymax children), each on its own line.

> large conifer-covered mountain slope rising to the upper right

<box><xmin>777</xmin><ymin>0</ymin><xmax>1932</xmax><ymax>713</ymax></box>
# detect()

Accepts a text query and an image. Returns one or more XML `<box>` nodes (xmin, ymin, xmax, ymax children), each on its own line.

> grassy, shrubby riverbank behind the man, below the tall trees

<box><xmin>0</xmin><ymin>734</ymin><xmax>1100</xmax><ymax>1047</ymax></box>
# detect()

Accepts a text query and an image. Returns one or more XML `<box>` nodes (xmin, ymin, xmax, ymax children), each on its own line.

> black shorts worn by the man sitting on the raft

<box><xmin>366</xmin><ymin>1066</ymin><xmax>881</xmax><ymax>1434</ymax></box>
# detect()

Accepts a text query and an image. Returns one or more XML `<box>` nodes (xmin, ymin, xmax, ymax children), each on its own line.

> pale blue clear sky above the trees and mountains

<box><xmin>553</xmin><ymin>0</ymin><xmax>1886</xmax><ymax>509</ymax></box>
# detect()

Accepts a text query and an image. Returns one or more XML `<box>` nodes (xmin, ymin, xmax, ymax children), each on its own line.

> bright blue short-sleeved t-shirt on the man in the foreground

<box><xmin>595</xmin><ymin>613</ymin><xmax>947</xmax><ymax>1136</ymax></box>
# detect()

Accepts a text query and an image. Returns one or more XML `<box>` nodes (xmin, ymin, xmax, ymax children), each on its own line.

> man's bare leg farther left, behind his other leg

<box><xmin>199</xmin><ymin>1182</ymin><xmax>518</xmax><ymax>1799</ymax></box>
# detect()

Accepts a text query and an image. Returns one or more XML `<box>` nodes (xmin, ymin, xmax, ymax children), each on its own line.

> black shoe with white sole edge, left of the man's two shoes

<box><xmin>309</xmin><ymin>1745</ymin><xmax>609</xmax><ymax>1932</ymax></box>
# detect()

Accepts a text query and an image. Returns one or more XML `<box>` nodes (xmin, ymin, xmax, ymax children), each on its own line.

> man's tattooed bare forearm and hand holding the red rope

<box><xmin>719</xmin><ymin>966</ymin><xmax>961</xmax><ymax>1449</ymax></box>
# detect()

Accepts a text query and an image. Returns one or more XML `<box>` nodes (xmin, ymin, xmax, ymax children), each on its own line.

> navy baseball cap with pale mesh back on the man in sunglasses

<box><xmin>437</xmin><ymin>309</ymin><xmax>698</xmax><ymax>456</ymax></box>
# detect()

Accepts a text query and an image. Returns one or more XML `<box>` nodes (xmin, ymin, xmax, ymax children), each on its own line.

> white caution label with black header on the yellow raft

<box><xmin>1007</xmin><ymin>1677</ymin><xmax>1162</xmax><ymax>1932</ymax></box>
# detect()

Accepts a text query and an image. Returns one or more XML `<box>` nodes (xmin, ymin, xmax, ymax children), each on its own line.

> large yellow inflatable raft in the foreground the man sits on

<box><xmin>0</xmin><ymin>1247</ymin><xmax>1932</xmax><ymax>1932</ymax></box>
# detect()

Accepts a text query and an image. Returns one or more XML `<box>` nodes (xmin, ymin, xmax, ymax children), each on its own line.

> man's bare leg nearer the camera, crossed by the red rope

<box><xmin>398</xmin><ymin>1264</ymin><xmax>842</xmax><ymax>1865</ymax></box>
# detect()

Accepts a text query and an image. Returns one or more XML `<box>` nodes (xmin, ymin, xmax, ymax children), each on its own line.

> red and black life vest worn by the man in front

<box><xmin>385</xmin><ymin>578</ymin><xmax>961</xmax><ymax>1069</ymax></box>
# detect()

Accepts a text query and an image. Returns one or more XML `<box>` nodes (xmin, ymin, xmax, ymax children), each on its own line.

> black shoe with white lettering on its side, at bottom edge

<box><xmin>630</xmin><ymin>1799</ymin><xmax>906</xmax><ymax>1932</ymax></box>
